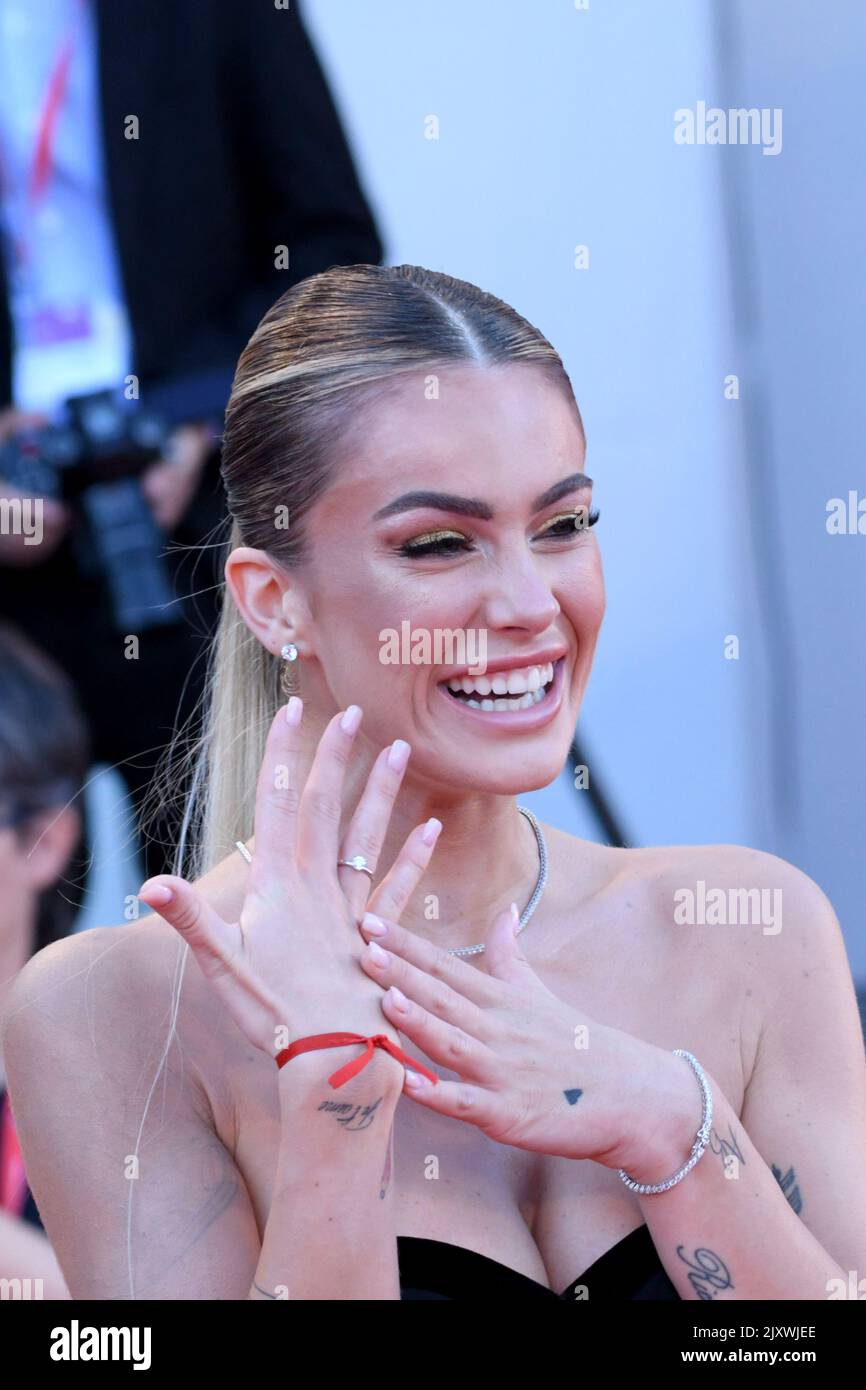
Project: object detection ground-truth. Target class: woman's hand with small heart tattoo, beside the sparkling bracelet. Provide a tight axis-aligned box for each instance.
[360,910,701,1183]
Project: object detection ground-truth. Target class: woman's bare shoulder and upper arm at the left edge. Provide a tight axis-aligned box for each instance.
[3,915,259,1298]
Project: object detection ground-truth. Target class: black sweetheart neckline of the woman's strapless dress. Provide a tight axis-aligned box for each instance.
[398,1225,680,1304]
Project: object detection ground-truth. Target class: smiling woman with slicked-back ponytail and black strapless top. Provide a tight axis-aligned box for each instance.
[7,265,866,1301]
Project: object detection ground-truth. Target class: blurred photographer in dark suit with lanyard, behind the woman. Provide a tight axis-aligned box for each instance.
[0,0,382,874]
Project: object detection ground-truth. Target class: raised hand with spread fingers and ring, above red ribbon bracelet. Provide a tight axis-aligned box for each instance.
[139,696,441,1065]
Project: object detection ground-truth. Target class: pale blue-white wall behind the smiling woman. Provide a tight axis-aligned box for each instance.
[82,0,866,979]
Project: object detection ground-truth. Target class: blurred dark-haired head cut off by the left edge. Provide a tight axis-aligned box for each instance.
[0,623,89,981]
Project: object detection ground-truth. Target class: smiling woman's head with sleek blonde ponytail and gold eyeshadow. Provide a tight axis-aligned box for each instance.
[166,265,605,873]
